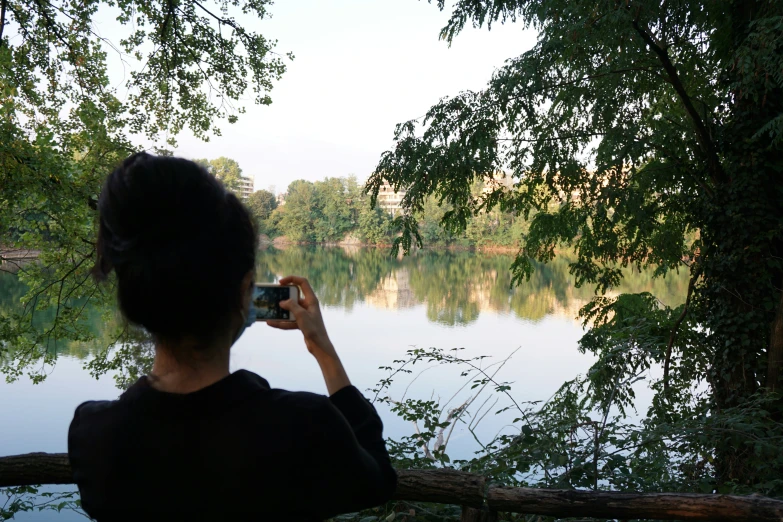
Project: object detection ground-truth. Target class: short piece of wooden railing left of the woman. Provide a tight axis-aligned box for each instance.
[0,453,73,487]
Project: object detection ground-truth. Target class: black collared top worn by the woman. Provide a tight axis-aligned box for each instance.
[68,370,397,522]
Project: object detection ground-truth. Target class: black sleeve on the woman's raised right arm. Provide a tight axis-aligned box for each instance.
[302,386,397,518]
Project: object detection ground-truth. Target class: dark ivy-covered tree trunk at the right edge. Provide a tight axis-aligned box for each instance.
[700,0,783,486]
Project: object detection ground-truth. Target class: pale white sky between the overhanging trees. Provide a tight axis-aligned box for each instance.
[167,0,536,193]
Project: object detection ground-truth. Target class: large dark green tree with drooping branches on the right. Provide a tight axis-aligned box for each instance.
[368,0,783,494]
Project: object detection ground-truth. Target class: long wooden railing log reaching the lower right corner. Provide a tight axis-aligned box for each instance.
[487,486,783,522]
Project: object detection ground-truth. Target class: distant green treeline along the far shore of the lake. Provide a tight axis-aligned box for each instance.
[246,177,527,247]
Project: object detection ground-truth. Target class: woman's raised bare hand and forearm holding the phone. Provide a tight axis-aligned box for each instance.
[266,276,351,395]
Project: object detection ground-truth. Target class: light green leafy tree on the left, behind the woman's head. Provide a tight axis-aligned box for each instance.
[0,0,285,379]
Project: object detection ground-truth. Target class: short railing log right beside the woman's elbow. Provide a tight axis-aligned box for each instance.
[394,469,487,507]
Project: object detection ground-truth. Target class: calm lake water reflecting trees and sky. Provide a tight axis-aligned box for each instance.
[0,247,688,520]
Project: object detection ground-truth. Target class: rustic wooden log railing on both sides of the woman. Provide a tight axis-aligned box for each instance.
[0,453,783,522]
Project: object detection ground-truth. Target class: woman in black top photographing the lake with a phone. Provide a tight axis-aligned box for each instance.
[68,153,397,522]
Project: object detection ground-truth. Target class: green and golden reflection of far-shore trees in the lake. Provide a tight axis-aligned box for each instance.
[258,247,687,325]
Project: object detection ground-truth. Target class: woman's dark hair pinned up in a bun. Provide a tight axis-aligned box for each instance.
[95,152,257,341]
